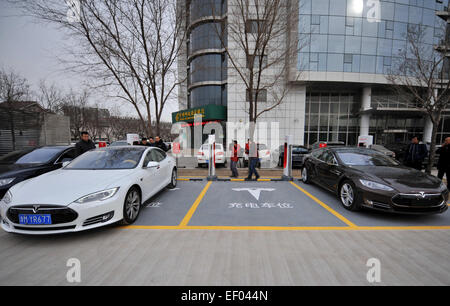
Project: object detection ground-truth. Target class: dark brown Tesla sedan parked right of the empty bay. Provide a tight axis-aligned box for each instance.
[302,147,449,214]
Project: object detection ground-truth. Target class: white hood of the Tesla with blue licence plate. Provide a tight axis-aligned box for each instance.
[10,169,132,205]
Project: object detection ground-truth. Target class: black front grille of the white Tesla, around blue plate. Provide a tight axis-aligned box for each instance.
[6,205,78,225]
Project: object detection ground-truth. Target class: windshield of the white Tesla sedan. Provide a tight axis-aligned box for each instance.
[65,148,144,170]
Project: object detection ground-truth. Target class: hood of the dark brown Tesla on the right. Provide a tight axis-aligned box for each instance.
[351,166,442,193]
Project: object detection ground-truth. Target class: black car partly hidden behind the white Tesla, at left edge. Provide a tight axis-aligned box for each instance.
[0,146,77,199]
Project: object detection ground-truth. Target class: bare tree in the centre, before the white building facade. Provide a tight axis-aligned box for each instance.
[210,0,305,137]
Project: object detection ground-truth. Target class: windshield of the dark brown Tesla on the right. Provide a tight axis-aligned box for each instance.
[337,152,399,166]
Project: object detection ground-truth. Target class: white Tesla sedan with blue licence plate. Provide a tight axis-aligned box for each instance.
[0,146,177,235]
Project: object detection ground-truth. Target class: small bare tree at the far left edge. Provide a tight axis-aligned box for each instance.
[0,70,30,151]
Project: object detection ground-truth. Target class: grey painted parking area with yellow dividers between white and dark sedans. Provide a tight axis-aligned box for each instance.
[129,181,450,230]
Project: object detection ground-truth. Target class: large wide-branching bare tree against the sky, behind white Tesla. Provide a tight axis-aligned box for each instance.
[10,0,183,135]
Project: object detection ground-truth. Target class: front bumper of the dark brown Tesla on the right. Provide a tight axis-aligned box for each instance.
[359,188,449,215]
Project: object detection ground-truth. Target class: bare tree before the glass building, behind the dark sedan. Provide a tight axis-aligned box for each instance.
[387,25,450,173]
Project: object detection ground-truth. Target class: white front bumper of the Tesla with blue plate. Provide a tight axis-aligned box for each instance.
[0,195,125,235]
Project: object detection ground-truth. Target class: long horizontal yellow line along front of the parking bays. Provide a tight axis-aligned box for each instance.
[122,225,450,231]
